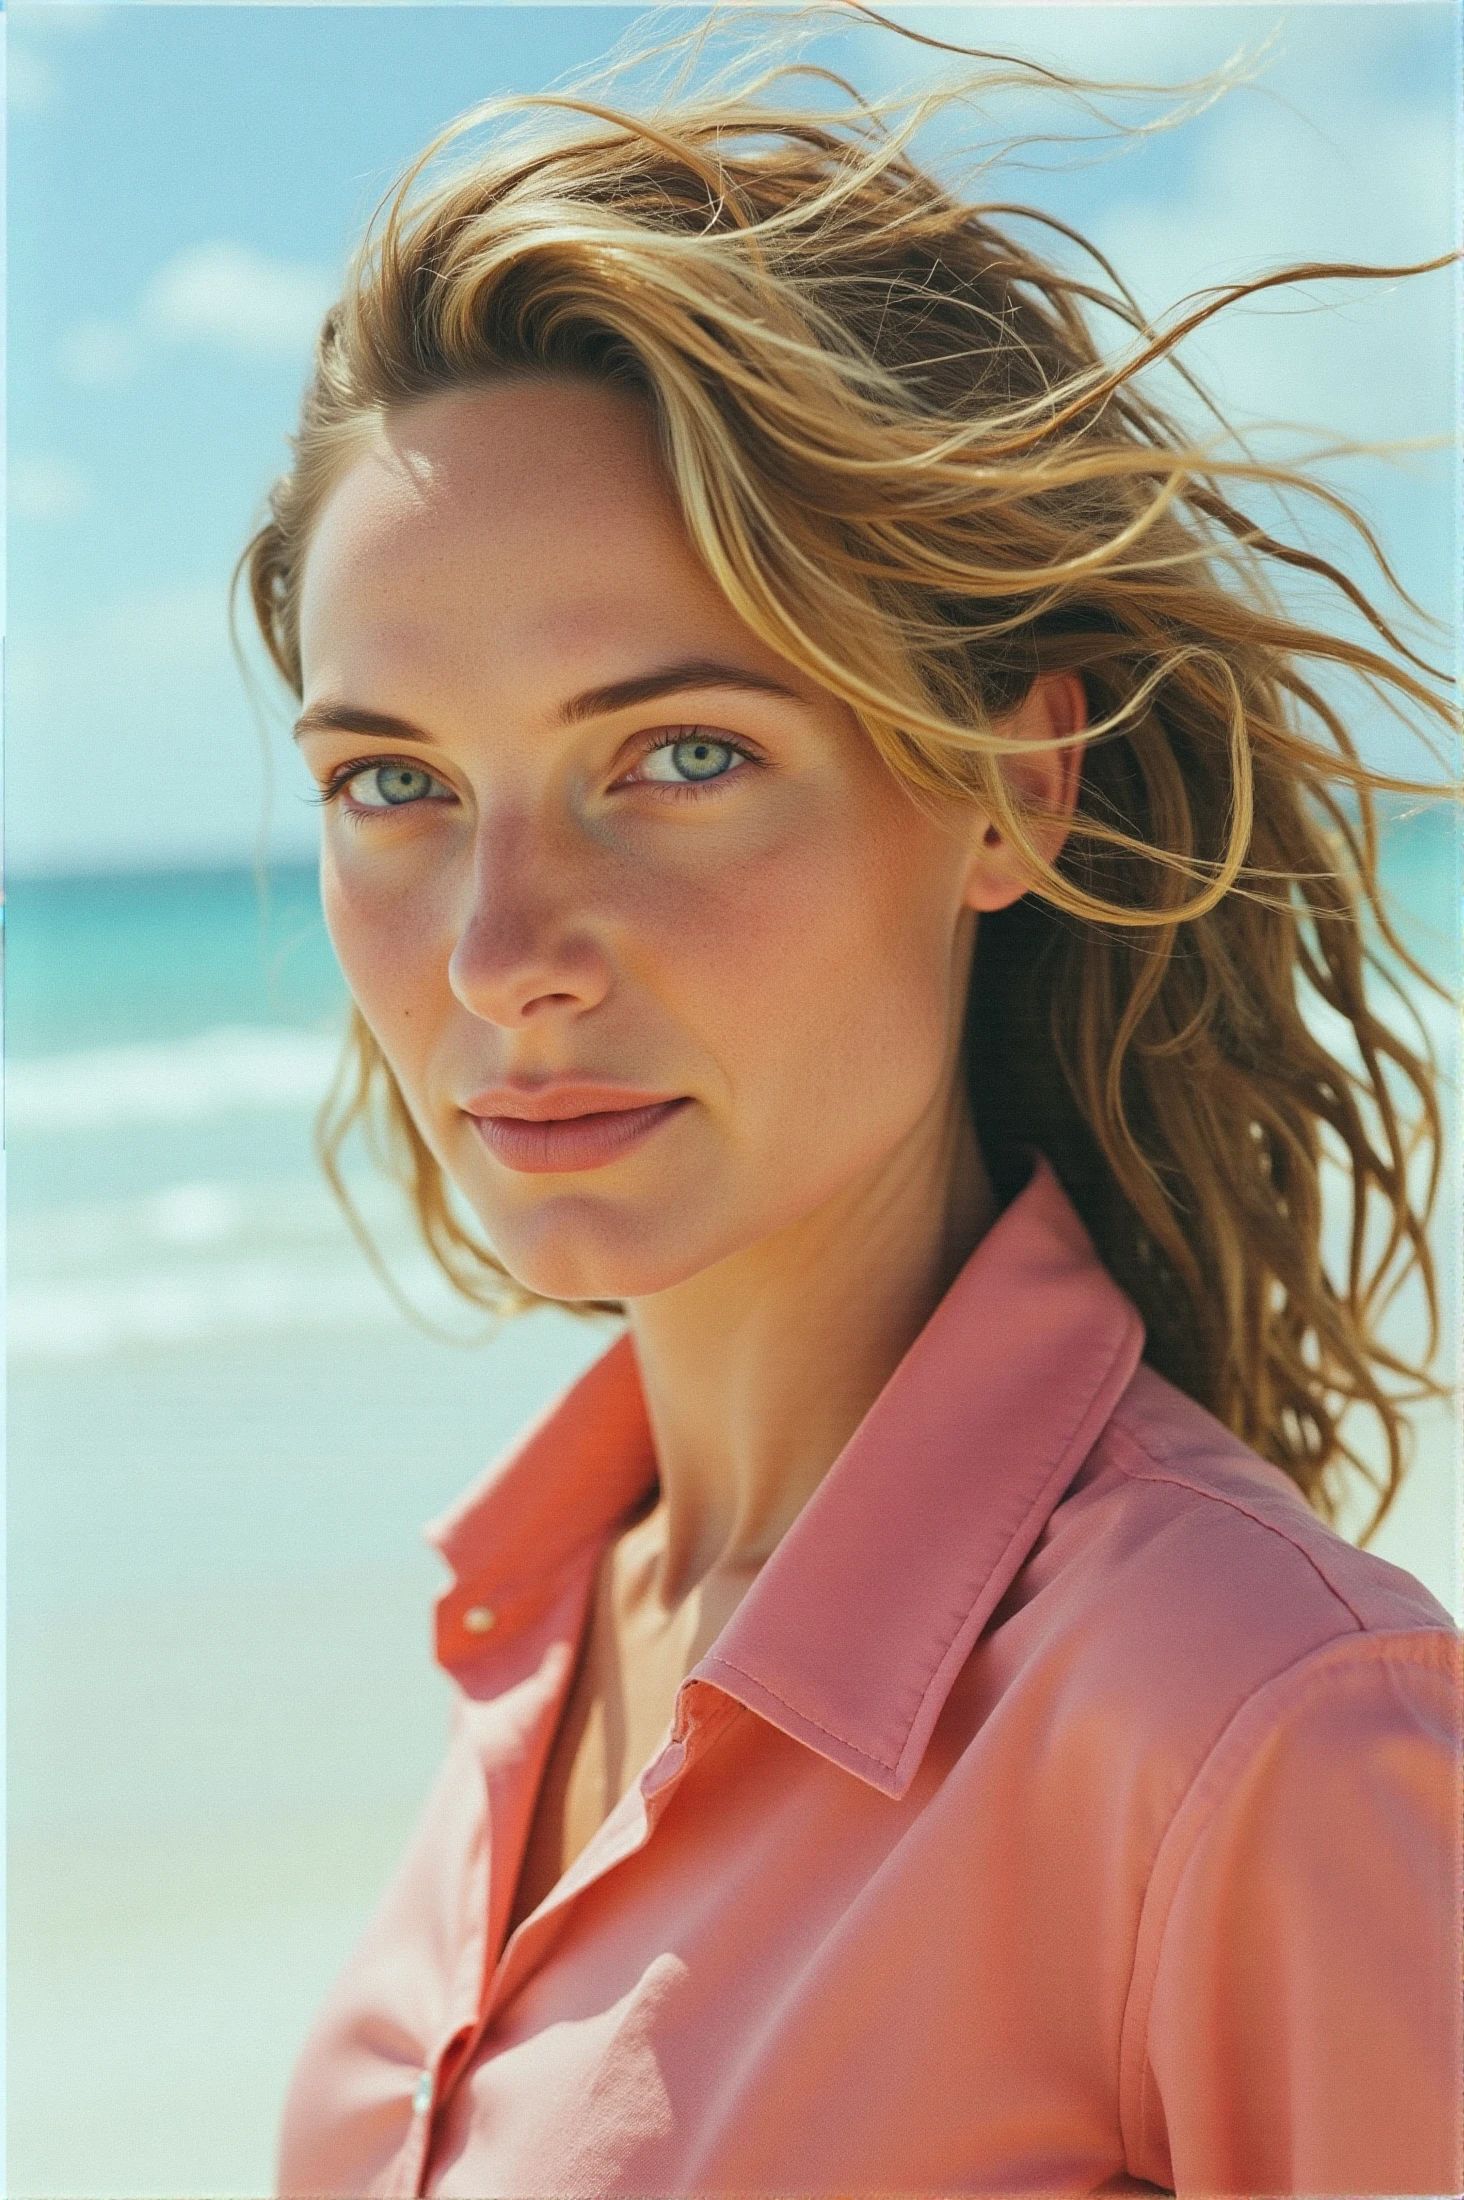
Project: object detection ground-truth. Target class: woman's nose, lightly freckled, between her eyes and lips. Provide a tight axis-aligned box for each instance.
[447,810,610,1030]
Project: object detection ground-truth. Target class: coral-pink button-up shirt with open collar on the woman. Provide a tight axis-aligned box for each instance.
[280,1162,1464,2200]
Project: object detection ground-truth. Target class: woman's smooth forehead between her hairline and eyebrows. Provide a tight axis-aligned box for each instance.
[299,378,751,690]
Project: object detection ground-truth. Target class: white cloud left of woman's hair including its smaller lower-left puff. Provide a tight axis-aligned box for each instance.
[57,238,337,389]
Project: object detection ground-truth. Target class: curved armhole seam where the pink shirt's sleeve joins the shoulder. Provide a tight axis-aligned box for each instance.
[1116,1628,1451,2176]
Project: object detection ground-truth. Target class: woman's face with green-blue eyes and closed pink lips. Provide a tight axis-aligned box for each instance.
[299,378,1025,1298]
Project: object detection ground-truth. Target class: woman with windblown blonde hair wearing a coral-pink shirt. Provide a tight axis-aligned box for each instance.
[236,21,1460,2196]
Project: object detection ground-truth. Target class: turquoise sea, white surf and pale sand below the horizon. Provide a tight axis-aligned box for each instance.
[7,810,1460,2196]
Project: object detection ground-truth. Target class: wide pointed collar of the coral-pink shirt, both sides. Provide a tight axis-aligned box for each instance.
[427,1155,1143,1797]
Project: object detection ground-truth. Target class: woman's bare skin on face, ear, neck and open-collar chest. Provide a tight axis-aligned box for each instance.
[302,381,1081,1821]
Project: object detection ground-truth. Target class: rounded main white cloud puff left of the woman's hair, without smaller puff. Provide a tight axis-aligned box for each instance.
[141,238,335,359]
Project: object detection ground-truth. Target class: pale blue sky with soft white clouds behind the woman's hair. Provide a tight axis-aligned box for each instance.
[7,0,1457,873]
